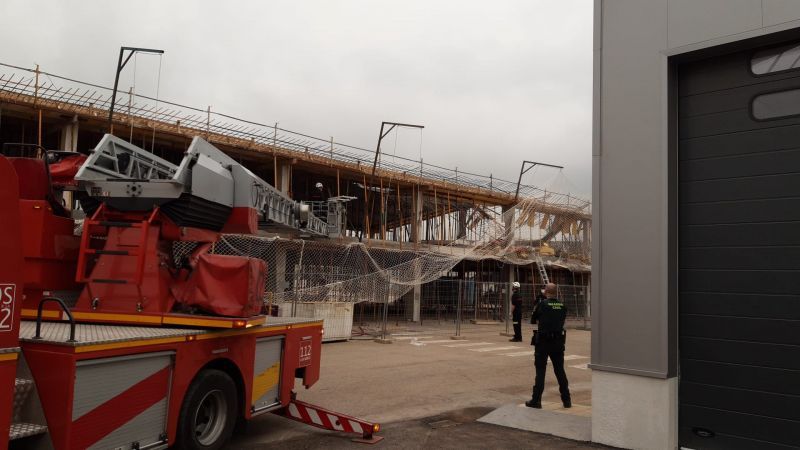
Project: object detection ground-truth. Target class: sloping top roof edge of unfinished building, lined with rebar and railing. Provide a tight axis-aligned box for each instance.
[0,63,591,205]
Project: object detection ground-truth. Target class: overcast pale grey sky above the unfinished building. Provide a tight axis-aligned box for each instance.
[0,0,592,198]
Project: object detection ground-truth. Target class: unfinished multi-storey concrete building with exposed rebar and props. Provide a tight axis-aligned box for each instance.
[0,64,591,331]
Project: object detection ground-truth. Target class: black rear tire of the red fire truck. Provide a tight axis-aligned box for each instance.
[175,369,238,450]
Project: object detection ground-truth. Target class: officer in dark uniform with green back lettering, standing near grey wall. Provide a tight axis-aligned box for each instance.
[525,283,572,408]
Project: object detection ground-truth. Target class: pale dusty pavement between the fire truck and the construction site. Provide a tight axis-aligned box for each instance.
[230,324,591,448]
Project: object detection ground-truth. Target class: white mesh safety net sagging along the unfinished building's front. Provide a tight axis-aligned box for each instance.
[175,195,591,304]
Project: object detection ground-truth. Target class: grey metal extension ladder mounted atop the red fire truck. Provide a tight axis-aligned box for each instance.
[75,134,340,237]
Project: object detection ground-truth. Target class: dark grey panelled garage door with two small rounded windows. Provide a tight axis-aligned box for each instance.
[678,40,800,449]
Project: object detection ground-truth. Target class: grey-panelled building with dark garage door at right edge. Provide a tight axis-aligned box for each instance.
[590,0,800,449]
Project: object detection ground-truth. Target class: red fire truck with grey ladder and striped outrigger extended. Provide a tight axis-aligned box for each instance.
[0,135,379,449]
